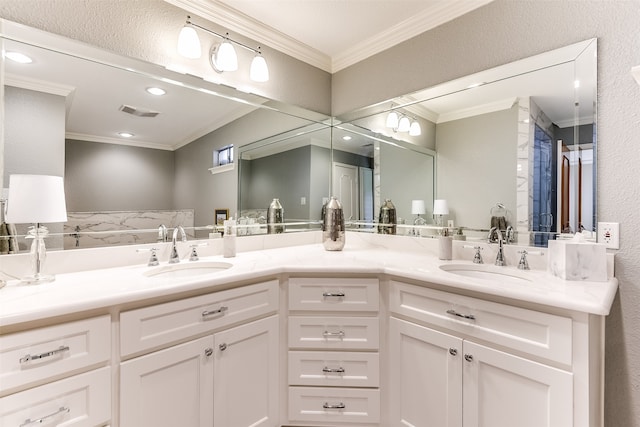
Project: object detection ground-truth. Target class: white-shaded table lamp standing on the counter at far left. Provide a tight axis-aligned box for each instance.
[6,175,67,284]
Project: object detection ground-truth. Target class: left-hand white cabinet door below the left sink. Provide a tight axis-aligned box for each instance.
[120,336,214,427]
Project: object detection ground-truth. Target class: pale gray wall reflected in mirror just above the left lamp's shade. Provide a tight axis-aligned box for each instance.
[4,86,65,181]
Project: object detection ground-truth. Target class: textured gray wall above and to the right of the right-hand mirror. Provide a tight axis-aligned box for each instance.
[332,0,640,427]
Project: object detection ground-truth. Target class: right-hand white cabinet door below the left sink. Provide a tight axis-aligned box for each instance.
[213,316,279,427]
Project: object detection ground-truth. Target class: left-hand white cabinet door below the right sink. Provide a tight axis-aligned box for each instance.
[389,318,462,427]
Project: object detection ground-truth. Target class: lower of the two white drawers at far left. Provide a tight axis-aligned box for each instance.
[0,368,111,427]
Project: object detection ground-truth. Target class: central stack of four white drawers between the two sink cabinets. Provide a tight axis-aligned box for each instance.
[288,277,381,426]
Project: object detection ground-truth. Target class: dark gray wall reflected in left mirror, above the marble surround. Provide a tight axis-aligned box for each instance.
[65,140,175,212]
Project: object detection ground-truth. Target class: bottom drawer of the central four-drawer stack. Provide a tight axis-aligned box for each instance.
[289,387,380,424]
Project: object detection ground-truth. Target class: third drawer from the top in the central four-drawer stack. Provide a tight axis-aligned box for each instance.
[289,351,380,387]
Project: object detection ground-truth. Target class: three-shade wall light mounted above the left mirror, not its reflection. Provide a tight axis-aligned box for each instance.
[178,16,269,82]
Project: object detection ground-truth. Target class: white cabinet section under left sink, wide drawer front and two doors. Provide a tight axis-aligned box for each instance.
[120,281,279,427]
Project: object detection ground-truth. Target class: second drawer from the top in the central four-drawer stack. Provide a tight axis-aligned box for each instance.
[289,316,380,350]
